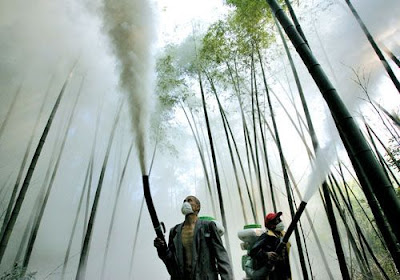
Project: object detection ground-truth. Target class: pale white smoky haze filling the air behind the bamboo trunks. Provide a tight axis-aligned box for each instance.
[0,0,400,279]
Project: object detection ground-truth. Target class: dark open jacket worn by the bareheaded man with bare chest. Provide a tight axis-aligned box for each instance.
[158,220,233,280]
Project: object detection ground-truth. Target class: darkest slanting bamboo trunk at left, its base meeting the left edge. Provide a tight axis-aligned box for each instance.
[0,63,76,263]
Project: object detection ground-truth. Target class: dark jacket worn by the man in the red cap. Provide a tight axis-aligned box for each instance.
[249,230,291,280]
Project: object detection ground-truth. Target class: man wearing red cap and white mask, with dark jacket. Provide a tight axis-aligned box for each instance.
[249,212,291,280]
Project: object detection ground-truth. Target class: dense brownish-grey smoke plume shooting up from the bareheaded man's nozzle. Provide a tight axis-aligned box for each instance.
[103,0,156,174]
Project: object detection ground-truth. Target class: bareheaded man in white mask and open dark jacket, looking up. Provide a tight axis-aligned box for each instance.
[154,196,233,280]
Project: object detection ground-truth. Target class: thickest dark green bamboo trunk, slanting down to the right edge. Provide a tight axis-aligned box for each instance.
[267,0,400,242]
